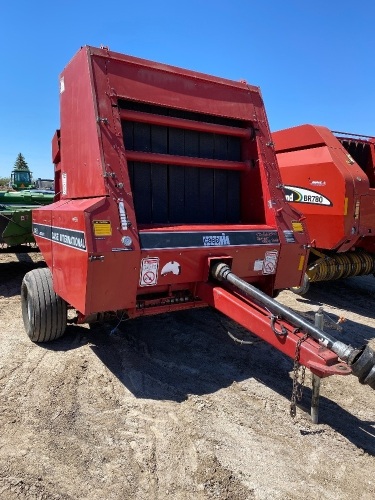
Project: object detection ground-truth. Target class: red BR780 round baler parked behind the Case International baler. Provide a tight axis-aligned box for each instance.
[272,125,375,294]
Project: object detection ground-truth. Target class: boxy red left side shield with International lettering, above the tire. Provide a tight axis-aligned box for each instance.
[33,197,140,315]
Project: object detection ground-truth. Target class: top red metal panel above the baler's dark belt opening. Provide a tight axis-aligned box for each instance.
[88,48,259,120]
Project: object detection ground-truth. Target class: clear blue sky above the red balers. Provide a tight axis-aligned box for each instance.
[0,0,375,177]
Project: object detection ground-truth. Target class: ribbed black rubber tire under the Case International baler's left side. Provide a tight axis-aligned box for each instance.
[21,267,67,342]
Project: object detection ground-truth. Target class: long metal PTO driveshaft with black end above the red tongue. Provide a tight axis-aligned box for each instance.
[211,262,375,389]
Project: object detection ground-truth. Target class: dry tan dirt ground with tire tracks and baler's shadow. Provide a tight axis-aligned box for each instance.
[0,253,375,500]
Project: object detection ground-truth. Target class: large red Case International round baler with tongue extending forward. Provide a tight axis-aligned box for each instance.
[21,47,375,414]
